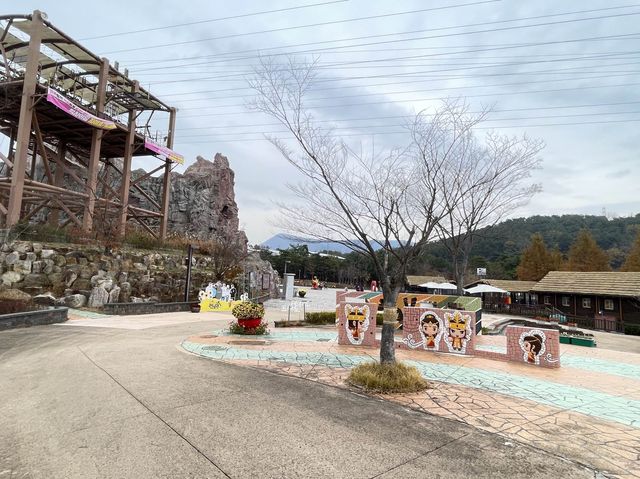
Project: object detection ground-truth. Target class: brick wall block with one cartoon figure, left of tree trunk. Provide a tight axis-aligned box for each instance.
[338,301,376,346]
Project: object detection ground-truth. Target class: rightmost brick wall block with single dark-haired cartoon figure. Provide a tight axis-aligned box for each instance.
[507,326,560,368]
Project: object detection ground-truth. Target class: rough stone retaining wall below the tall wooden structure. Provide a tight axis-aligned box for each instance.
[0,242,278,308]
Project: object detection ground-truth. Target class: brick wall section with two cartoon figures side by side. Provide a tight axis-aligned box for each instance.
[402,307,476,355]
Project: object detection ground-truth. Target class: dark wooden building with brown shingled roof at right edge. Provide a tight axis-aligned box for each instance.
[531,271,640,324]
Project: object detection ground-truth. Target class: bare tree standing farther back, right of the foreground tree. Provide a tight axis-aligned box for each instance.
[412,101,544,295]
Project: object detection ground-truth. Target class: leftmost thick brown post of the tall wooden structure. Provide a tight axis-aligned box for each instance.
[6,10,43,227]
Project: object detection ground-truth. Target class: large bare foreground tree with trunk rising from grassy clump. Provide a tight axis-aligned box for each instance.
[249,59,492,363]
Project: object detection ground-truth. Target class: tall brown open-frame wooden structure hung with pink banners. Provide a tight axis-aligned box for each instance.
[0,10,183,238]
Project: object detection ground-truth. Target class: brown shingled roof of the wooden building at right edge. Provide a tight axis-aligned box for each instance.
[533,271,640,297]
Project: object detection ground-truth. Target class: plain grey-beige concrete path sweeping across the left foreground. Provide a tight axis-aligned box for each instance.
[0,315,595,479]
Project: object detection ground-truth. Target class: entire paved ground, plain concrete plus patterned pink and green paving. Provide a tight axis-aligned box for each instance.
[0,302,640,479]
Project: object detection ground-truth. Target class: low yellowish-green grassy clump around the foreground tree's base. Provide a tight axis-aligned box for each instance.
[347,362,428,393]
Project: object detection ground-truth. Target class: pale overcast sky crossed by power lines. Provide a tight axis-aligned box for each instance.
[5,0,640,244]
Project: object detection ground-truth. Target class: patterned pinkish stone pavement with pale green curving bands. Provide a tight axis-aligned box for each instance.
[182,328,640,478]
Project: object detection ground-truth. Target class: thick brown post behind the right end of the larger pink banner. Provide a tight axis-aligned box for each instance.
[82,58,109,233]
